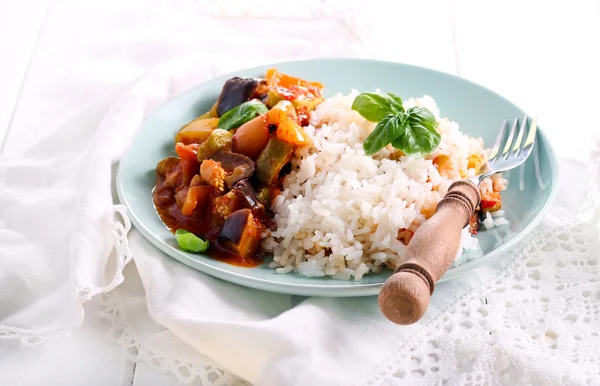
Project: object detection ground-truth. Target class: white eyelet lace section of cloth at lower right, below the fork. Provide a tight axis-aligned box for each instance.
[357,225,600,385]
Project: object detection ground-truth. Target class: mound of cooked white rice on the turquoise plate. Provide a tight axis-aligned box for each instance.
[262,91,493,280]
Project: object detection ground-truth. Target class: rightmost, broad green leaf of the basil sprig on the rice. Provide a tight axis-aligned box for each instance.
[391,107,442,158]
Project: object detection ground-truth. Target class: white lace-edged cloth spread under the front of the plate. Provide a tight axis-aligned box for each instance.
[106,153,600,385]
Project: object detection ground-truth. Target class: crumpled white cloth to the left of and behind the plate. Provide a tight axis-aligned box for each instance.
[0,0,370,343]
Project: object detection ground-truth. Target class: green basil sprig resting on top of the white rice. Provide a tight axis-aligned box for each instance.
[352,93,441,157]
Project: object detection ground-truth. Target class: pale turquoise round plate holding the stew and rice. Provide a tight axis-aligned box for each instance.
[117,59,558,296]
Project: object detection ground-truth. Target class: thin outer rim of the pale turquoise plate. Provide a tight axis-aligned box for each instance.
[115,57,559,297]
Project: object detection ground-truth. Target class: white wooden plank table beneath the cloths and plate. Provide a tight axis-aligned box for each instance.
[0,0,600,386]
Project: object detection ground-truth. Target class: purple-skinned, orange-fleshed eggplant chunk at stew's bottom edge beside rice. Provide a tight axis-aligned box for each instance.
[219,209,260,258]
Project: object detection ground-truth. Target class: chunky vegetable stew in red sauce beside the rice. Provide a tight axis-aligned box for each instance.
[152,68,323,266]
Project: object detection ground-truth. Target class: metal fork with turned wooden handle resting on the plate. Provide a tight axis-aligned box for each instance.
[379,115,537,324]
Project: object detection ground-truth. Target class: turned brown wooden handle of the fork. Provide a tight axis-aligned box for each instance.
[379,181,481,324]
